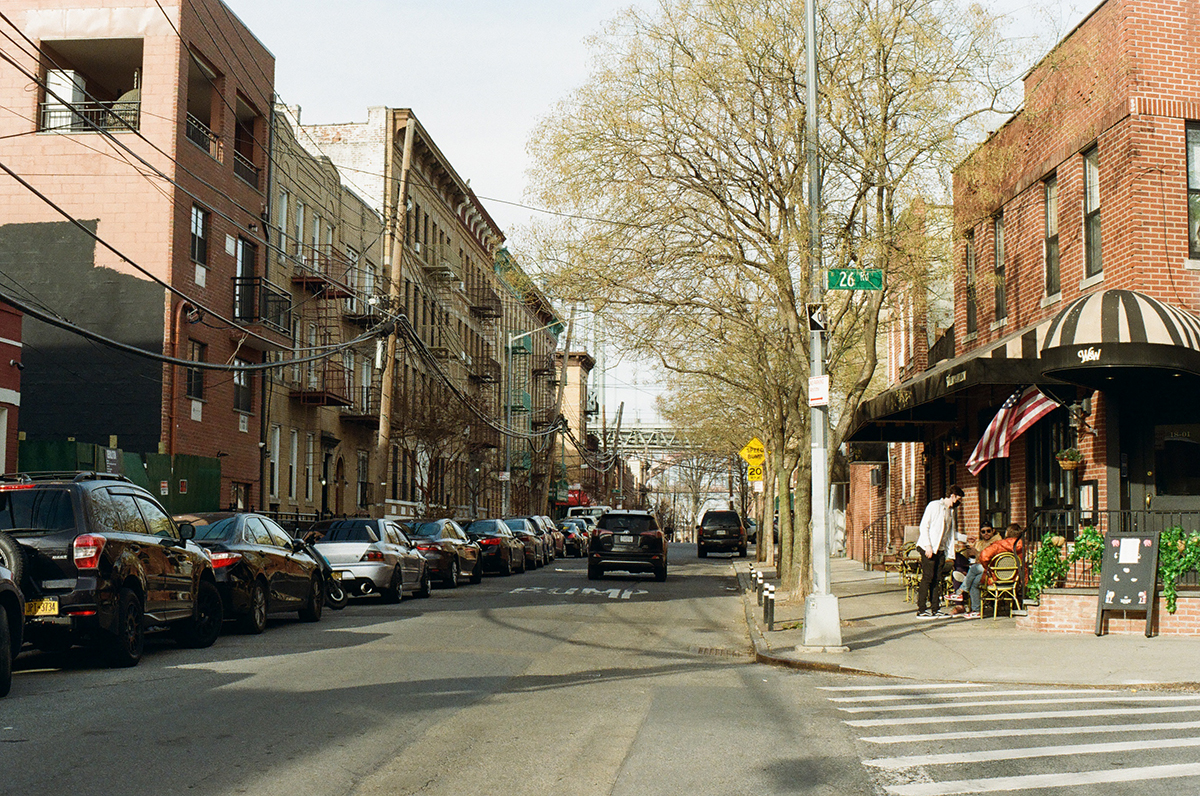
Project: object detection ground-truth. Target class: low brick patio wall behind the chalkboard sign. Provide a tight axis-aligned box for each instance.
[1016,588,1200,636]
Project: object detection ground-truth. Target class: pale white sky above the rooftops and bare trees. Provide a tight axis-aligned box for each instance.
[226,0,1099,424]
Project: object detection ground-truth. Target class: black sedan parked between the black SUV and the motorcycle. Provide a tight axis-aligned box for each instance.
[175,511,325,634]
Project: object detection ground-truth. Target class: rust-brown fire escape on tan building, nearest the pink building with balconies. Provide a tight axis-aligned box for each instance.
[288,245,354,407]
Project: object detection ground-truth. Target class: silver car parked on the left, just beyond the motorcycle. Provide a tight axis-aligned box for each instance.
[306,517,432,603]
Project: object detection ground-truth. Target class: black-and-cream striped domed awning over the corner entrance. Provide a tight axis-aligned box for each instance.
[1042,289,1200,387]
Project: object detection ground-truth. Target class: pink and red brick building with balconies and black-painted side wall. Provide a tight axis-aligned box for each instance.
[0,0,276,507]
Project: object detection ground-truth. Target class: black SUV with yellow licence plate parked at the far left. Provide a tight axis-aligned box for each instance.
[0,472,223,666]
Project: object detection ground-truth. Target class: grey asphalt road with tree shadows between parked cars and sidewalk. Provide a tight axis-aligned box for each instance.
[0,545,880,796]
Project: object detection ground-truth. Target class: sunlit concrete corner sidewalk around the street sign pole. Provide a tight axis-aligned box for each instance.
[733,558,1200,688]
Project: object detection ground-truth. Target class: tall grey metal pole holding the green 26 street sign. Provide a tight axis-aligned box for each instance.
[803,0,841,647]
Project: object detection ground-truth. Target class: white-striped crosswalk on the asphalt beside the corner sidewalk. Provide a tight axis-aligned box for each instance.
[821,682,1200,796]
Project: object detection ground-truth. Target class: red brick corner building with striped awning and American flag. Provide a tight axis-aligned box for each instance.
[851,0,1200,576]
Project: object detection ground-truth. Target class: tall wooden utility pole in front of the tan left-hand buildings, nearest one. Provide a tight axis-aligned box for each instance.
[376,112,416,516]
